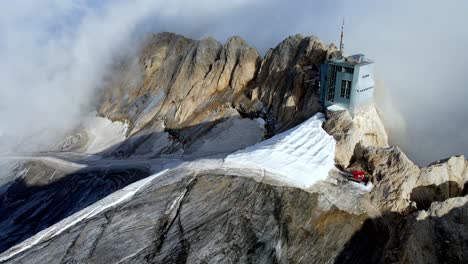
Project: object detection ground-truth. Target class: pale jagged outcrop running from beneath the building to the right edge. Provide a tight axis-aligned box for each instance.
[324,105,468,213]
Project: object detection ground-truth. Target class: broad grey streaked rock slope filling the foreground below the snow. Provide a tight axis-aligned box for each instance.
[0,165,468,263]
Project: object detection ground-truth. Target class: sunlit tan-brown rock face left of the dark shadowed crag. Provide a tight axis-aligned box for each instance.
[99,33,260,156]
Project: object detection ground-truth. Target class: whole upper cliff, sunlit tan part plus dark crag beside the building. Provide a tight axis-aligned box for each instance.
[99,33,327,156]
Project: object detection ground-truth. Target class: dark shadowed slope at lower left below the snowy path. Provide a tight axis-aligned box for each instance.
[0,161,149,252]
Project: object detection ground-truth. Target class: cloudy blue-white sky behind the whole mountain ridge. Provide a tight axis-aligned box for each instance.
[0,0,468,163]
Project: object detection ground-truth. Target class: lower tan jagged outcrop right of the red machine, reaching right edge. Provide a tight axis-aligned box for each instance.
[350,145,468,213]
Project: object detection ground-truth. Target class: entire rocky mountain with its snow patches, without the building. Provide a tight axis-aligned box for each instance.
[0,33,468,263]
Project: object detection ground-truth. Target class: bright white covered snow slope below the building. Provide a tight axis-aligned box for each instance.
[225,113,335,188]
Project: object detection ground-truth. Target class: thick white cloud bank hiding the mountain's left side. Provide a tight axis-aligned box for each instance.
[0,0,252,151]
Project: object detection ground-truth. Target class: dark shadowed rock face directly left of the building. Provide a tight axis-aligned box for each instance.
[252,35,328,131]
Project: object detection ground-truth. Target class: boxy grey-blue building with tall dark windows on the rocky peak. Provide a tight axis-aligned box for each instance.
[320,54,375,112]
